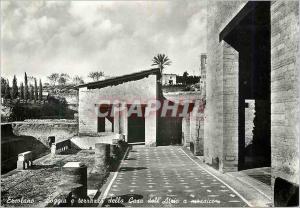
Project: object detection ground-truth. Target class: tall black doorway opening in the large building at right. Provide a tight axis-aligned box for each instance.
[220,1,271,170]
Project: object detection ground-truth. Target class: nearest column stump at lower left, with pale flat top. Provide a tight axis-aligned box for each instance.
[61,162,87,199]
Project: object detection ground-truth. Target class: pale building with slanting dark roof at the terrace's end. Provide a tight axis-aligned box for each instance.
[78,70,160,145]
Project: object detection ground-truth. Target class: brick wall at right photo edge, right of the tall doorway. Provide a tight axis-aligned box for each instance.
[271,1,300,188]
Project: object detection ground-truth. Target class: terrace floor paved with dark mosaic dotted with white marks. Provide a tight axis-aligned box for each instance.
[103,146,247,207]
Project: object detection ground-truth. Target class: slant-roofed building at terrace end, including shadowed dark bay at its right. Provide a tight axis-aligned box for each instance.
[78,69,196,146]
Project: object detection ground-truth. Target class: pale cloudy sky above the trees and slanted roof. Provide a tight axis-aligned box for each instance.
[1,0,206,81]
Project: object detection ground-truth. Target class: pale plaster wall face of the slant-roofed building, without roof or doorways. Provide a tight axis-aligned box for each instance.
[78,75,157,145]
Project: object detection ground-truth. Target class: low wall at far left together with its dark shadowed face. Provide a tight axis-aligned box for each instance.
[1,119,78,173]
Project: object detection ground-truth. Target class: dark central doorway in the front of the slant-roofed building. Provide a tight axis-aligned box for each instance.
[128,107,145,143]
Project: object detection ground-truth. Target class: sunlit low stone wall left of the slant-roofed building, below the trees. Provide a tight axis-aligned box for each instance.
[12,119,78,146]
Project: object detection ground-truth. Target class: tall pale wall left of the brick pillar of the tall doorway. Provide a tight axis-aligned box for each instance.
[204,1,246,171]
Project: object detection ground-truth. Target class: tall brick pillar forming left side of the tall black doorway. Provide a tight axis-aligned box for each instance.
[219,41,239,172]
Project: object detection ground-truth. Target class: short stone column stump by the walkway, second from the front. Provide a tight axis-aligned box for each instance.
[95,143,110,174]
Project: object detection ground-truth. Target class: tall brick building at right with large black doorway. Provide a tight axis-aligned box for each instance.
[204,1,300,205]
